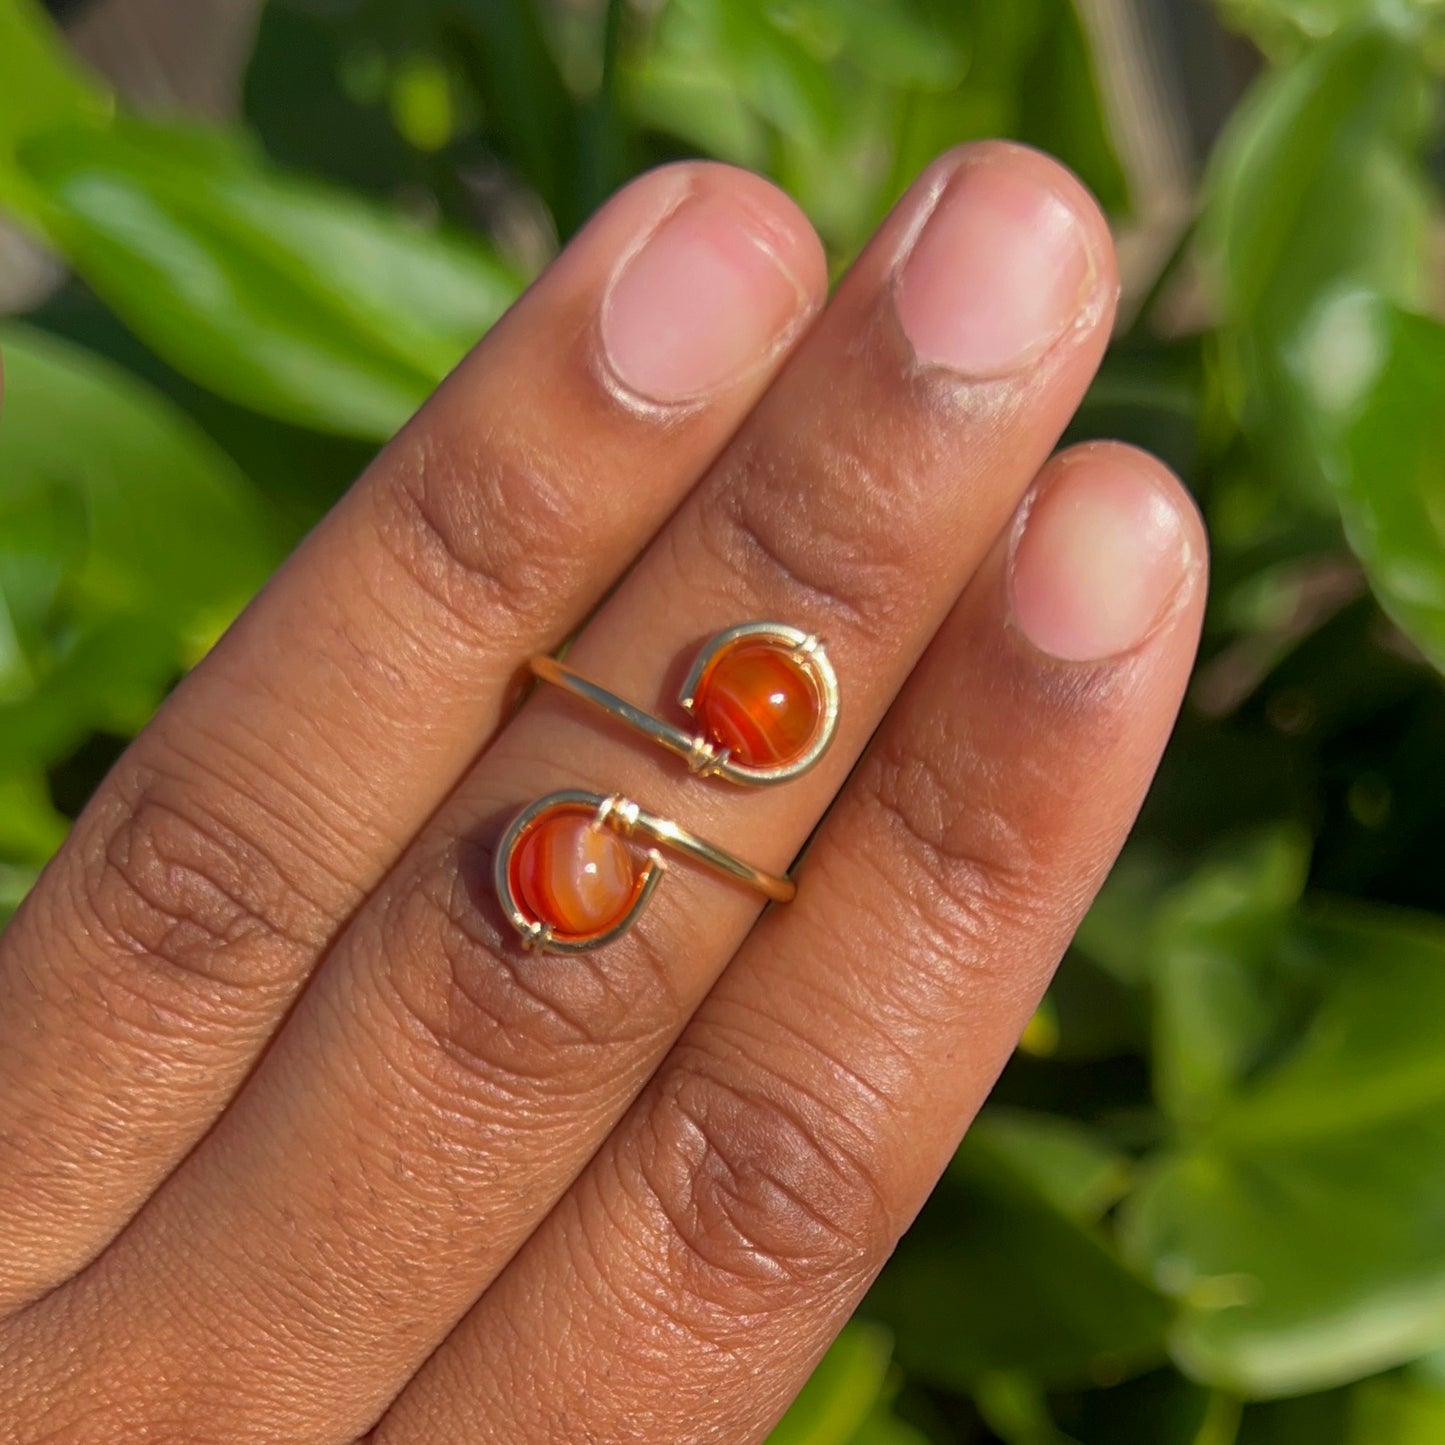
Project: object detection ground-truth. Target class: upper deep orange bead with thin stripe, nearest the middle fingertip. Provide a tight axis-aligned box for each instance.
[695,640,822,769]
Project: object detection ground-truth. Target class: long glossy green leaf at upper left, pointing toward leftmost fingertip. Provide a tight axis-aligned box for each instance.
[9,121,519,439]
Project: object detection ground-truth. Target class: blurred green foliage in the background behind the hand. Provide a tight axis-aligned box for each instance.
[0,0,1445,1445]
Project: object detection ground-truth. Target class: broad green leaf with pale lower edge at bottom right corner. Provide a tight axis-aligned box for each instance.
[1124,906,1445,1397]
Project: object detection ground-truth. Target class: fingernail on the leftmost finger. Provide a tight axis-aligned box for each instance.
[601,197,808,403]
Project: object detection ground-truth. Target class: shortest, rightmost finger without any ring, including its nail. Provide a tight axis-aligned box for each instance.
[371,447,1204,1445]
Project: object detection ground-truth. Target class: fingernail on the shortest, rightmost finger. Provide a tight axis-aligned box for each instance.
[1012,455,1192,662]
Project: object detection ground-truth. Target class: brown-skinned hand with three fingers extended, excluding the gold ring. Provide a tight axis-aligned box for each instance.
[0,145,1205,1445]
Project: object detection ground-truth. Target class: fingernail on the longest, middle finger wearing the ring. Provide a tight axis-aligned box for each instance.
[897,162,1097,379]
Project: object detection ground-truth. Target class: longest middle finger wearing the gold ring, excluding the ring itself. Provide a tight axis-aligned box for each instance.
[2,146,1114,1442]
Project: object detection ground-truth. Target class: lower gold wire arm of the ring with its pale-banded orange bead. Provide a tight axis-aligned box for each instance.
[493,790,796,954]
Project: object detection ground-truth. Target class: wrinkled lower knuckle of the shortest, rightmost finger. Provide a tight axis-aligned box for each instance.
[637,1056,897,1325]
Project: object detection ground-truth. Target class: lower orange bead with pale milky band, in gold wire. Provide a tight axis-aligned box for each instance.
[512,808,642,938]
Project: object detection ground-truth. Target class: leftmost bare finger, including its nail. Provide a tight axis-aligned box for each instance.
[0,165,825,1308]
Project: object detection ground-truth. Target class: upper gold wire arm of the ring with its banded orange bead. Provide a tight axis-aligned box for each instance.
[529,623,838,786]
